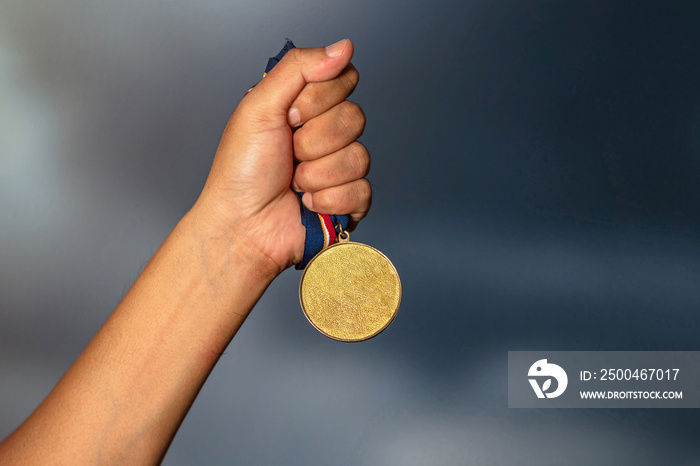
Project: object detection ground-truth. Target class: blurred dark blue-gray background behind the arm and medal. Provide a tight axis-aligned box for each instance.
[0,0,700,465]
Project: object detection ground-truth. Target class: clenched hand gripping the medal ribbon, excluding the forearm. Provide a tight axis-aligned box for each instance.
[195,39,371,273]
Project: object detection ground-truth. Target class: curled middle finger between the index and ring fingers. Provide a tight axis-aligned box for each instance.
[294,100,366,162]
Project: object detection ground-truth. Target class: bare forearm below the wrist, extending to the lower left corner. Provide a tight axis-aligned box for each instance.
[0,206,277,464]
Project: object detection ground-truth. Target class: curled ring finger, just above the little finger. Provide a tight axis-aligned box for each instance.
[294,141,370,193]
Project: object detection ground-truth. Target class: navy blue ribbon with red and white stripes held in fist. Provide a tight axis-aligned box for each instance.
[248,39,350,270]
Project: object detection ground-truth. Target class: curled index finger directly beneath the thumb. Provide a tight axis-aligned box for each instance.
[288,63,360,128]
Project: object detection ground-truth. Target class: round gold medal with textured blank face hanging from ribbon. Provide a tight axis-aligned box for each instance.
[299,241,401,341]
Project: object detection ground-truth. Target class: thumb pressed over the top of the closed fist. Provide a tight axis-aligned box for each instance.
[246,39,353,120]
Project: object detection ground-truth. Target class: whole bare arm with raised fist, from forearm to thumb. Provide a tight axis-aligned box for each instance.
[0,40,371,465]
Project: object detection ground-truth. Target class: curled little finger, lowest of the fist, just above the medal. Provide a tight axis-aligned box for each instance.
[302,178,372,231]
